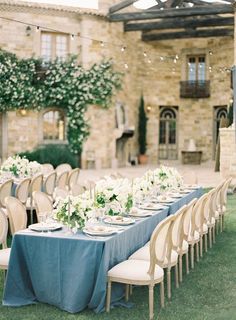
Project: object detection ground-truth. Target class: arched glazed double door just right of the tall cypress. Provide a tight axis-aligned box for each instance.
[159,107,178,160]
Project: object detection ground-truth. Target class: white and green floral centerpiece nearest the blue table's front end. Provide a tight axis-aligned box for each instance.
[54,191,94,233]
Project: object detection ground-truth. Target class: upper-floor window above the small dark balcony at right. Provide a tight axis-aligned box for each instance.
[187,55,206,81]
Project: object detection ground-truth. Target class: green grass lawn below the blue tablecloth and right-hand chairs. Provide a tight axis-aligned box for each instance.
[0,195,236,320]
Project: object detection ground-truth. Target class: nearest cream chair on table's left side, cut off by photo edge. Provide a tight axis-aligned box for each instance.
[0,209,11,270]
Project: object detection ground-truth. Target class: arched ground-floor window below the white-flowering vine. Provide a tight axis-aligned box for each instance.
[43,109,65,141]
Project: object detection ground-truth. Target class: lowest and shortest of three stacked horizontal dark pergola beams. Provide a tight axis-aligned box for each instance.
[142,28,234,41]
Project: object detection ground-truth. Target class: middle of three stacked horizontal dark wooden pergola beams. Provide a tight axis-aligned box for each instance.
[124,17,234,31]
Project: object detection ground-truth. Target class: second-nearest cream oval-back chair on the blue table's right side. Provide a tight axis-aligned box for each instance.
[129,205,186,299]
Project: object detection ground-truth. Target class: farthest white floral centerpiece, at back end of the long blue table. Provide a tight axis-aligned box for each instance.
[153,166,183,191]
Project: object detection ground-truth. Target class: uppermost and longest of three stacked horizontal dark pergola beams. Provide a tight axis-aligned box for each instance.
[108,5,234,21]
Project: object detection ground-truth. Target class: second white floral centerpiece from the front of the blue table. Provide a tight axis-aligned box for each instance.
[94,177,133,216]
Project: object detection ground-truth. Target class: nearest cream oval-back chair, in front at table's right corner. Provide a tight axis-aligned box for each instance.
[106,216,174,319]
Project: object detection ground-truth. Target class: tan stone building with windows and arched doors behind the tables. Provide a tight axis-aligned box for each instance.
[0,0,234,168]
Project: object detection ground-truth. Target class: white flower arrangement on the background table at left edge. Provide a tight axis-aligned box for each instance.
[0,155,41,178]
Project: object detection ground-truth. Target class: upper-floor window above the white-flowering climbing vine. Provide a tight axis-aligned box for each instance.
[41,32,69,62]
